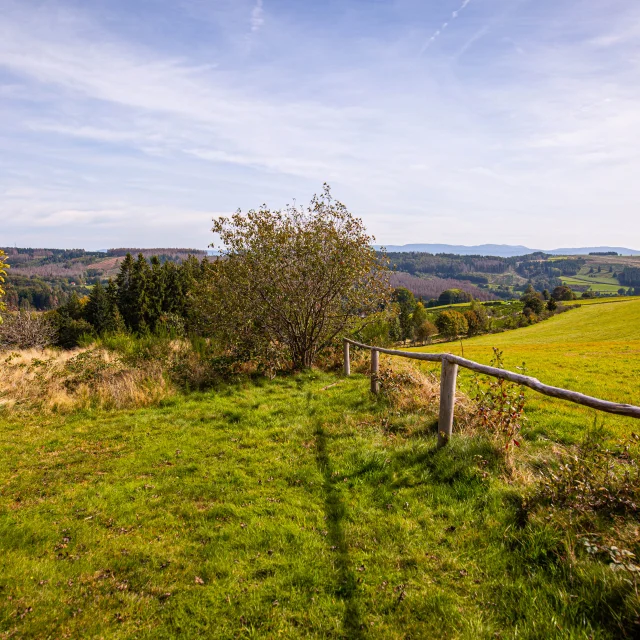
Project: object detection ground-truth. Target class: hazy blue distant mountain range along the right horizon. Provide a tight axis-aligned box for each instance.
[376,244,640,258]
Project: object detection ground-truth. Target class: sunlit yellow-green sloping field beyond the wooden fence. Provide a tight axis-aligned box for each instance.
[418,298,640,440]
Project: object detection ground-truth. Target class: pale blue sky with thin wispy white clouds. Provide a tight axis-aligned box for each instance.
[0,0,640,249]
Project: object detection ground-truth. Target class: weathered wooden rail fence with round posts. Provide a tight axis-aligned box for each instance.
[344,338,640,447]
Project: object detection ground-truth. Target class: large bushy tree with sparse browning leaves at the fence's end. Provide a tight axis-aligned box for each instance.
[200,185,390,368]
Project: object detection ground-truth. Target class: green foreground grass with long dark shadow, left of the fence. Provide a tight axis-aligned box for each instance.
[0,373,636,638]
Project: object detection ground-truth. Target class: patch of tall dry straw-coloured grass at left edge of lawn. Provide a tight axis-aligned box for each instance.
[0,348,174,413]
